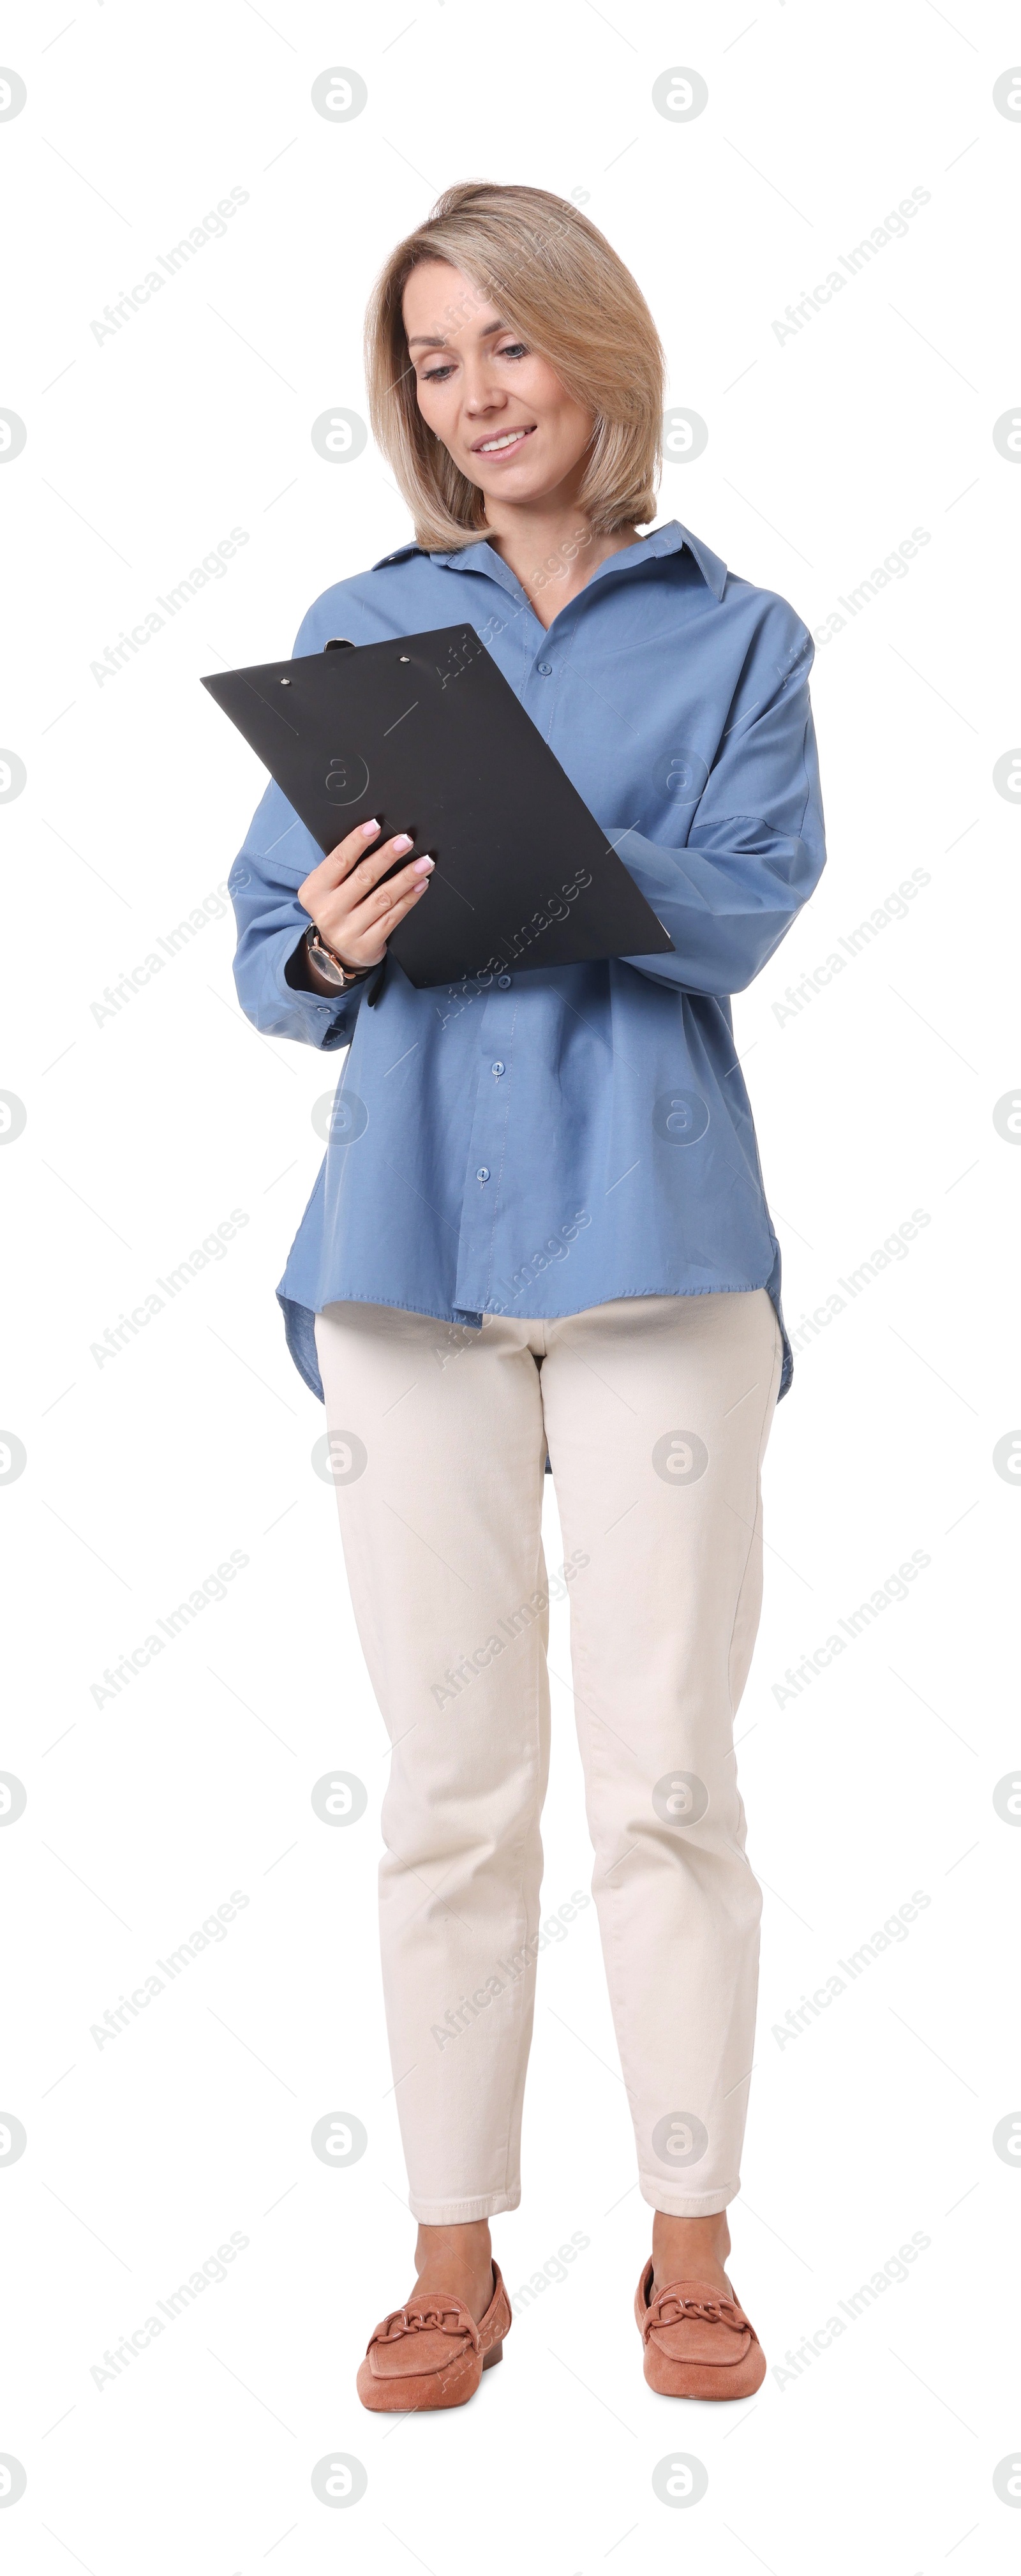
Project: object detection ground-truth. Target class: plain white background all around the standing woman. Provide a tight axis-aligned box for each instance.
[0,0,1021,2576]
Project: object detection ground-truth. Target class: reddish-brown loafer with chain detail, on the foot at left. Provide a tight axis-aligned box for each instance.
[359,2265,511,2414]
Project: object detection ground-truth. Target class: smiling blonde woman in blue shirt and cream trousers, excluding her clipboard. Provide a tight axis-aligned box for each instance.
[232,186,823,2411]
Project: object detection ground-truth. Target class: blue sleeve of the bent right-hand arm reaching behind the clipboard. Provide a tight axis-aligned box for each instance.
[609,603,825,994]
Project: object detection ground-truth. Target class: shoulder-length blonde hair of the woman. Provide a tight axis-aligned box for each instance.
[366,181,665,554]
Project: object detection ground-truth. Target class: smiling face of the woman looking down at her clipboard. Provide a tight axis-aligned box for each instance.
[402,260,595,505]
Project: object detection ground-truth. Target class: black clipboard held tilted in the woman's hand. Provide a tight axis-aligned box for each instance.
[201,626,673,984]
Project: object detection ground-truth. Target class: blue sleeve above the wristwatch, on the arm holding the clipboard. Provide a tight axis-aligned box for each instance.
[227,783,366,1049]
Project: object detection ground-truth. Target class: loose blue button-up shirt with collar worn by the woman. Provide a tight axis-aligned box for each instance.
[230,520,825,1397]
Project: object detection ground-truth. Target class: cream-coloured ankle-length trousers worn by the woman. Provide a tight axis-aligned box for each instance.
[317,1288,781,2226]
